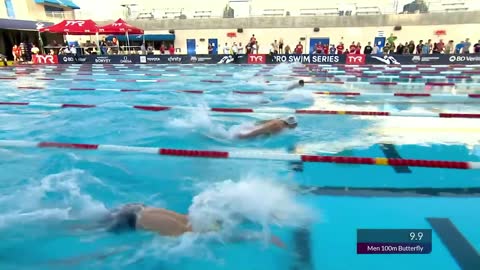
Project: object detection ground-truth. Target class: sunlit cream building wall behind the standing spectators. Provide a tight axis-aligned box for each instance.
[146,24,480,54]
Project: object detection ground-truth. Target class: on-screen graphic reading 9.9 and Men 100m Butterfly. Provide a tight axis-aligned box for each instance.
[357,229,432,254]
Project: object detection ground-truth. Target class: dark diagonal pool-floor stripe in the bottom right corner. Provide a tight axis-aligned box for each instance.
[426,218,480,270]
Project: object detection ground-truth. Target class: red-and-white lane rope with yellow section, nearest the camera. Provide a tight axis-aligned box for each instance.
[0,140,480,170]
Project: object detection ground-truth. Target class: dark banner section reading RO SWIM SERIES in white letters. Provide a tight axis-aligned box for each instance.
[267,54,345,64]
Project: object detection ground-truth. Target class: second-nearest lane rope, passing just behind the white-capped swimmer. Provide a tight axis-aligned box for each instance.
[0,101,480,119]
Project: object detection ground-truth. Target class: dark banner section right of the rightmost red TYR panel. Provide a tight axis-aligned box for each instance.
[366,54,480,65]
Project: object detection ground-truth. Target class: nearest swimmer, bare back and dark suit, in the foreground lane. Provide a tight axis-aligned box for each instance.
[77,203,285,248]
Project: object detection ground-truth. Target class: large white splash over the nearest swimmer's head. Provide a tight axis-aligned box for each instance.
[188,177,313,233]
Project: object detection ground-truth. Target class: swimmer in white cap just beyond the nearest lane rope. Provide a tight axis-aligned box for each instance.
[236,116,298,139]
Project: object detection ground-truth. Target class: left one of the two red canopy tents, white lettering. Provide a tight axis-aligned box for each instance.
[39,20,98,35]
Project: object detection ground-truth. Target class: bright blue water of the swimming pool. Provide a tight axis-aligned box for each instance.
[0,64,480,269]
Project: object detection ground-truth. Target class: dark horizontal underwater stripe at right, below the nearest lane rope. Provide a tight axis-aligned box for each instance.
[298,185,480,198]
